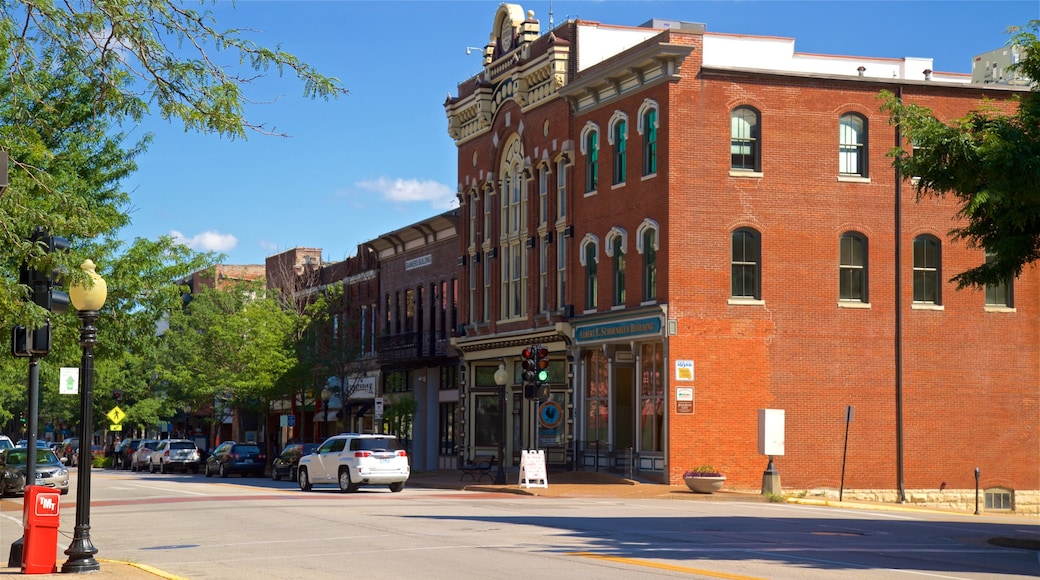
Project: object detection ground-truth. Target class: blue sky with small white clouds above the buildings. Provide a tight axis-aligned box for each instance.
[121,0,1040,264]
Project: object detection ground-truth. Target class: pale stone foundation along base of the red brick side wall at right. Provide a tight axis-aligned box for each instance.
[783,487,1040,516]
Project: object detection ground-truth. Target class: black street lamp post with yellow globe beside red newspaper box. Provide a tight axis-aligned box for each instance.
[61,260,108,574]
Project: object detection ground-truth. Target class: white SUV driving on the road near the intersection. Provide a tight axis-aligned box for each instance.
[298,433,410,492]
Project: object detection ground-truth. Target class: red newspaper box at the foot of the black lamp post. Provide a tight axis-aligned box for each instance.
[22,485,61,574]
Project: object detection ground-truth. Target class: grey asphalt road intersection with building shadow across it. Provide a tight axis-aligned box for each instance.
[0,471,1040,580]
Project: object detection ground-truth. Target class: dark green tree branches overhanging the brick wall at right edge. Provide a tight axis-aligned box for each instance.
[882,21,1040,288]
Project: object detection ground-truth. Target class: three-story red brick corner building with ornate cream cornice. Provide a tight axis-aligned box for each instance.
[445,4,1040,511]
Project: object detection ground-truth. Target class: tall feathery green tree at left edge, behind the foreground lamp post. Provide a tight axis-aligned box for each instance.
[0,0,346,436]
